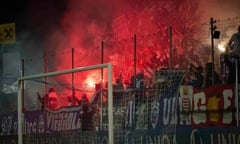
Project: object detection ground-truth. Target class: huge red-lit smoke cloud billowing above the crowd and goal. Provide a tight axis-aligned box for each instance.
[16,0,240,109]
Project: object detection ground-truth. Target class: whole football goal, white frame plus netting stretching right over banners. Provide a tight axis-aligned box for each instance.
[18,64,185,144]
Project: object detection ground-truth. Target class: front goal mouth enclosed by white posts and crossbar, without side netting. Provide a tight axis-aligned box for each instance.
[17,64,114,144]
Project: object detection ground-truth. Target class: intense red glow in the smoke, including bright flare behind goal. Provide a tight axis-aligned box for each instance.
[37,0,212,103]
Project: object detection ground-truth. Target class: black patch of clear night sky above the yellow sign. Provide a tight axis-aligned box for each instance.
[0,0,66,38]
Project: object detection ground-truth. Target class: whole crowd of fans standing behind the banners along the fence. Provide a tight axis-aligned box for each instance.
[37,23,240,130]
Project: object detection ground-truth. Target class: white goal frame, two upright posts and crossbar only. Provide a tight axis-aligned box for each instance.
[17,63,114,144]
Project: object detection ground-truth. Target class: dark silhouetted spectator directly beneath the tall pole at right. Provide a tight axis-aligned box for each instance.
[205,63,221,88]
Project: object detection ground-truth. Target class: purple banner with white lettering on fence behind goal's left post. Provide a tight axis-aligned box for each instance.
[0,107,81,135]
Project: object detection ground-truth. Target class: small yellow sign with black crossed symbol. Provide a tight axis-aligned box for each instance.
[0,23,16,44]
